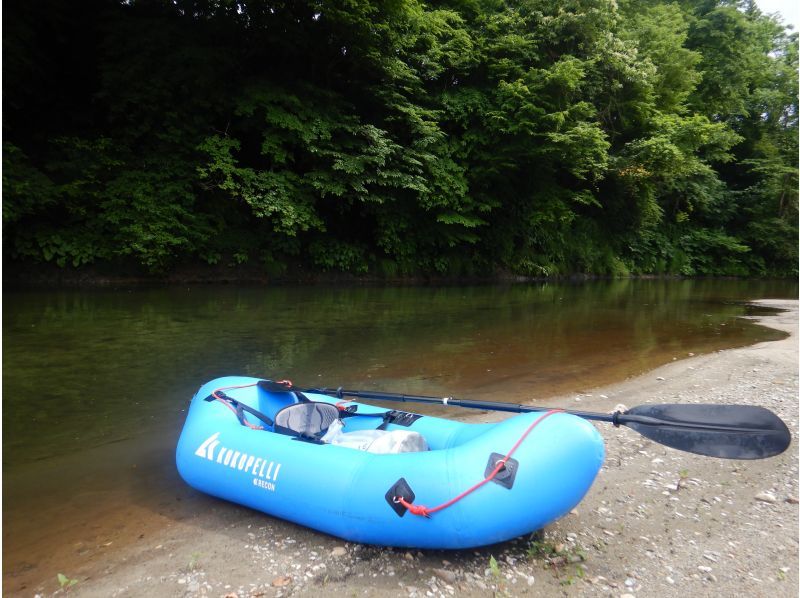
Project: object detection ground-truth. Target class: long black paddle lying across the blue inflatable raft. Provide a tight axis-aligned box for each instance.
[258,380,792,459]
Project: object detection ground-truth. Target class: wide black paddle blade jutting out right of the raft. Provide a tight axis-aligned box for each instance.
[617,404,792,459]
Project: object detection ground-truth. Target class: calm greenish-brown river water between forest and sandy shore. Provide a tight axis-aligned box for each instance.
[2,280,798,595]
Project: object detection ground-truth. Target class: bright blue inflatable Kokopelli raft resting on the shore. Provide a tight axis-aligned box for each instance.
[177,377,604,548]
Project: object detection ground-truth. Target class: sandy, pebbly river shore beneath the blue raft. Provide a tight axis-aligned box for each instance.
[21,300,798,598]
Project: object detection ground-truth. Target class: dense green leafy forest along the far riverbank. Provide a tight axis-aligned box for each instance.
[3,0,798,279]
